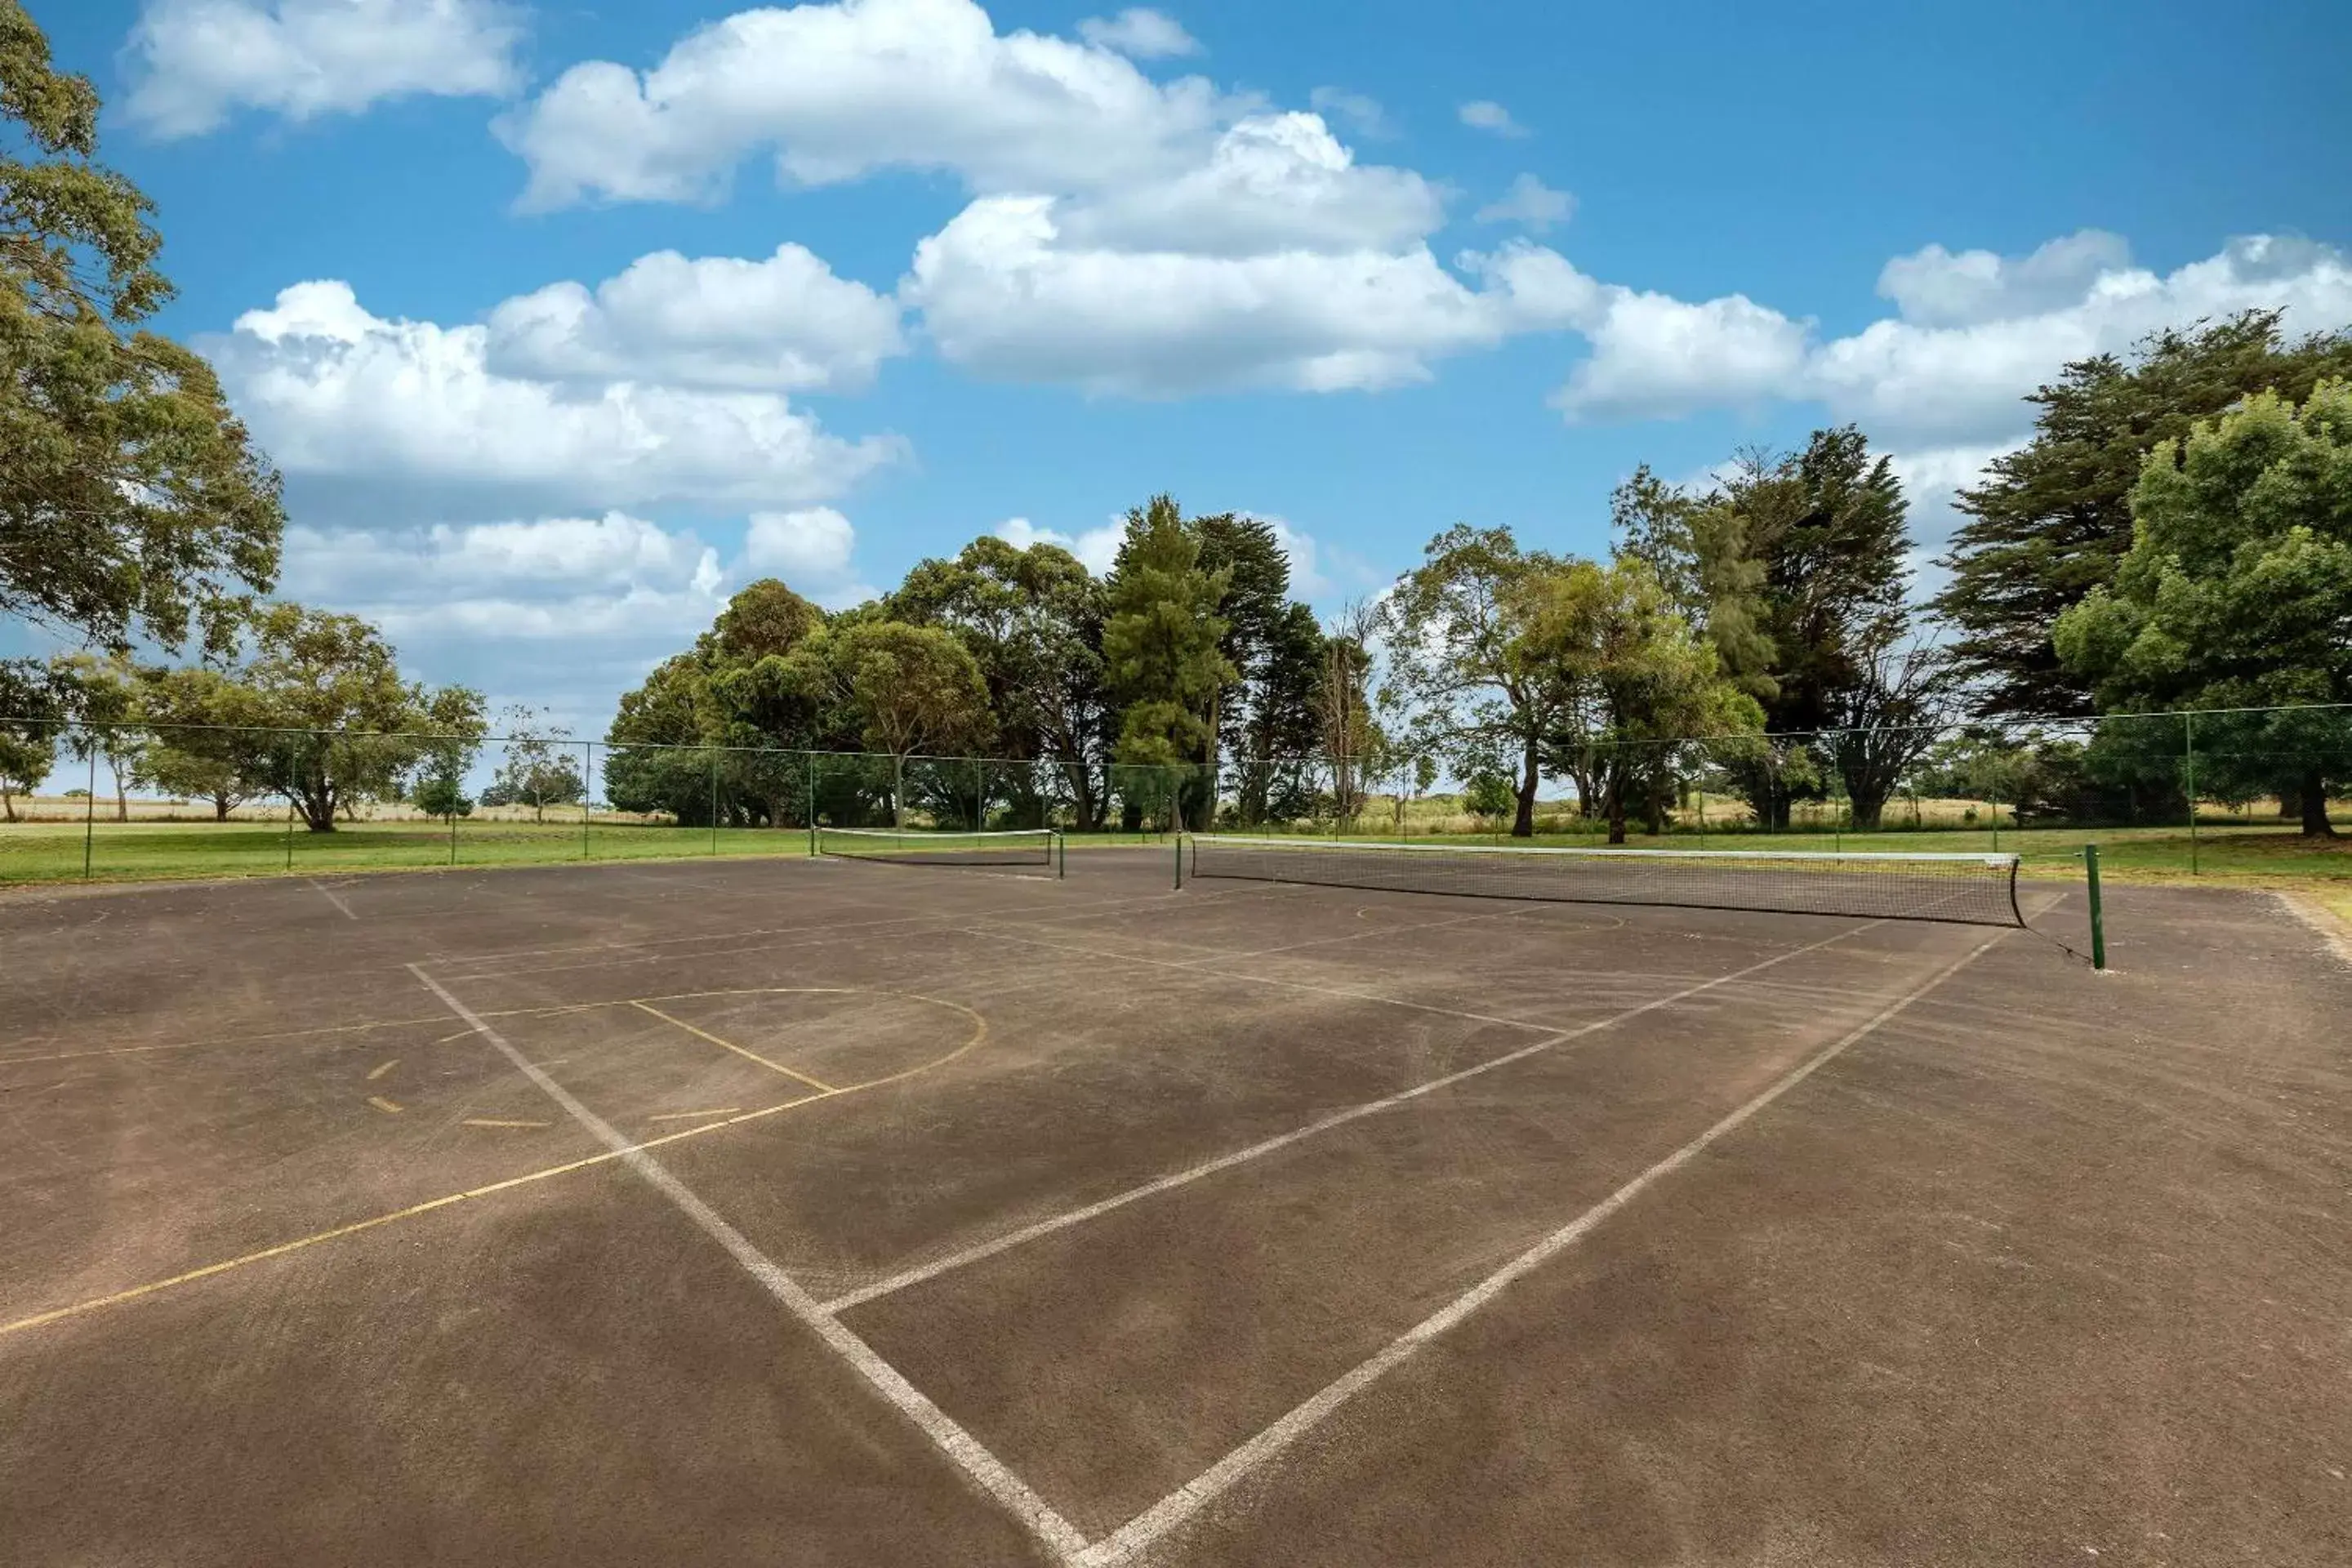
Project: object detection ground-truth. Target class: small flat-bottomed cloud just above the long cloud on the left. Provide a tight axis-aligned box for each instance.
[489,244,906,393]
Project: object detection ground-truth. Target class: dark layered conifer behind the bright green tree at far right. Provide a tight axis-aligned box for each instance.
[1936,310,2352,717]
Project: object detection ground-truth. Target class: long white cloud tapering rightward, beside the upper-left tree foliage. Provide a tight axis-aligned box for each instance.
[207,280,901,514]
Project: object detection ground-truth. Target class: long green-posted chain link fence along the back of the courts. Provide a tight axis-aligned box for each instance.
[0,706,2352,881]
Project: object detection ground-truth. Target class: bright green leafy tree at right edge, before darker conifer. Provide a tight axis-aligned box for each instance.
[2053,381,2352,837]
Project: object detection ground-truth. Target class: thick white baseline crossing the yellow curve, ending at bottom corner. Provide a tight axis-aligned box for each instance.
[407,964,1087,1561]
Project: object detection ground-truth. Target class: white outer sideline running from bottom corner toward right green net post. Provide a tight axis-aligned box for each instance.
[1075,931,2009,1568]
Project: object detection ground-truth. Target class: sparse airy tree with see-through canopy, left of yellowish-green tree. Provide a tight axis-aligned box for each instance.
[1383,522,1574,840]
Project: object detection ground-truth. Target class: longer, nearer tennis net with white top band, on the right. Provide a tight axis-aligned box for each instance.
[1187,832,2025,926]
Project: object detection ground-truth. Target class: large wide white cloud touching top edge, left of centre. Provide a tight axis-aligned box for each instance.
[501,0,1246,207]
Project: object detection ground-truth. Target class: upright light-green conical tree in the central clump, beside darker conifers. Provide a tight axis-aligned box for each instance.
[1103,496,1240,827]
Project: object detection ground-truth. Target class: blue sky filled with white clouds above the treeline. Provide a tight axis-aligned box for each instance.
[19,0,2352,733]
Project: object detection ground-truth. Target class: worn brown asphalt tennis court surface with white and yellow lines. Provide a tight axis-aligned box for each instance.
[0,851,2352,1566]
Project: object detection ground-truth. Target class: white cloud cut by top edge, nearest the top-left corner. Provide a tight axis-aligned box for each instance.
[125,0,522,136]
